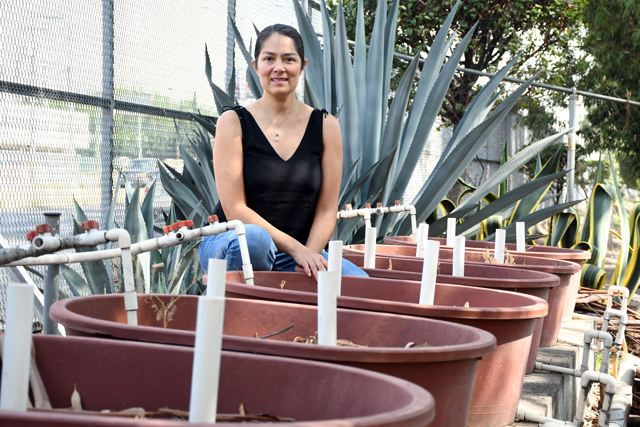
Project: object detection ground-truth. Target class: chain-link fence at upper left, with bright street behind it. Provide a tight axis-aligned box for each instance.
[0,0,321,328]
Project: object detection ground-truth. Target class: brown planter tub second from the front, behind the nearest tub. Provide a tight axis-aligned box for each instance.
[51,295,496,427]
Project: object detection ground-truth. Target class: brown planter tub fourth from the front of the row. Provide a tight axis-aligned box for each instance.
[344,251,556,373]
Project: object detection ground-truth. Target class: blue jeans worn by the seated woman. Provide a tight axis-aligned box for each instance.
[198,224,368,277]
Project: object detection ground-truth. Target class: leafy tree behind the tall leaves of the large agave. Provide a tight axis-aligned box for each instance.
[332,0,585,138]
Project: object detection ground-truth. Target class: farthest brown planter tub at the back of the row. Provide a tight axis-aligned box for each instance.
[384,236,591,322]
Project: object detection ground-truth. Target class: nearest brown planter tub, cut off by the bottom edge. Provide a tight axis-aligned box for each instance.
[0,335,435,427]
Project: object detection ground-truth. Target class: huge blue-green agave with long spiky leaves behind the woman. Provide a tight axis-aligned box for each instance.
[165,0,576,247]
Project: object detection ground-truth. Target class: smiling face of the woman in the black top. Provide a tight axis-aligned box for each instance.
[253,34,307,95]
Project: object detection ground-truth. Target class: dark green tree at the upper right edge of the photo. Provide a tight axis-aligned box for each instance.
[580,0,640,188]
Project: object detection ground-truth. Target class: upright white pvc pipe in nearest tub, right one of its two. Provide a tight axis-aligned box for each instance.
[189,295,224,423]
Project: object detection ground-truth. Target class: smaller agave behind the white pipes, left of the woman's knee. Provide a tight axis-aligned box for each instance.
[61,173,203,296]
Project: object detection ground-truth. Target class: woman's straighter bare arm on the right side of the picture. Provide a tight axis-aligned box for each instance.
[306,115,342,254]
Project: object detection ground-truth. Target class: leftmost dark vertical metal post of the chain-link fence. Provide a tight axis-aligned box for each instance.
[100,0,115,224]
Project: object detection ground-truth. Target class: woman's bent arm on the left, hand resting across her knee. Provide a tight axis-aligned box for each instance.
[213,111,322,276]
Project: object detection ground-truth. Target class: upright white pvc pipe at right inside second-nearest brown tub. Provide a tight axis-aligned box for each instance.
[318,271,338,345]
